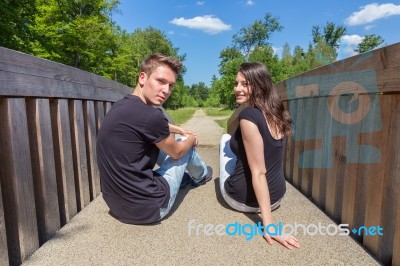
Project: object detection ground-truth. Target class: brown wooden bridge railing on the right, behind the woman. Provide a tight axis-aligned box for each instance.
[277,43,400,265]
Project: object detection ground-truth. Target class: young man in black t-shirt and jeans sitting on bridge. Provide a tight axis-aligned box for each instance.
[97,54,212,224]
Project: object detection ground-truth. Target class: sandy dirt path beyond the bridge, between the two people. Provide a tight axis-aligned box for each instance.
[181,109,224,147]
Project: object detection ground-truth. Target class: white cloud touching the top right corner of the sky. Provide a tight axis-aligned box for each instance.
[345,3,400,26]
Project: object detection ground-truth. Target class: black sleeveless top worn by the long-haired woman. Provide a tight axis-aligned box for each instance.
[224,107,286,207]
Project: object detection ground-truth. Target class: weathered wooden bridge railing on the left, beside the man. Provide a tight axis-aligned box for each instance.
[0,47,131,265]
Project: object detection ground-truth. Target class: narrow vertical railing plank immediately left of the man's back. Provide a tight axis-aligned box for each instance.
[83,101,100,200]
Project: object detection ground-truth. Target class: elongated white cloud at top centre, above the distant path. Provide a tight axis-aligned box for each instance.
[169,15,231,34]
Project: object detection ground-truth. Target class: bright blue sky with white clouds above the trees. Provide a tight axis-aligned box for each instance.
[113,0,400,86]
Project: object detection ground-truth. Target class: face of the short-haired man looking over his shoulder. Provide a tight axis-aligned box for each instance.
[139,65,176,105]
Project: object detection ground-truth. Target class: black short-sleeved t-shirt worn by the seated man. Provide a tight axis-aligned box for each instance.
[97,95,170,224]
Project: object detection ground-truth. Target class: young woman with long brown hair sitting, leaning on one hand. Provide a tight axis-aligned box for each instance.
[220,62,300,249]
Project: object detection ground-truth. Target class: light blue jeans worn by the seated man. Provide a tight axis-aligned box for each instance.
[155,138,207,220]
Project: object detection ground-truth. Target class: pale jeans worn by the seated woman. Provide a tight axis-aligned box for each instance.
[219,134,283,213]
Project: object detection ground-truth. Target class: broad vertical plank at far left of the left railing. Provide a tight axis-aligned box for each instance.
[0,98,39,265]
